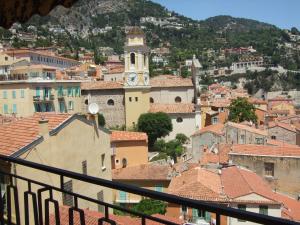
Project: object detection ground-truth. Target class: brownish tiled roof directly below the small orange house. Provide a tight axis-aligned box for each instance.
[112,164,170,180]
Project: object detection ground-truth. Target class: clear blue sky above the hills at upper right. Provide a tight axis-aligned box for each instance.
[153,0,300,29]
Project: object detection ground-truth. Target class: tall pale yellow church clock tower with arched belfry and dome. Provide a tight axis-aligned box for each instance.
[124,27,150,128]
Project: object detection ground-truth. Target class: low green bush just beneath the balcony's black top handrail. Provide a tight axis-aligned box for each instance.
[132,199,167,215]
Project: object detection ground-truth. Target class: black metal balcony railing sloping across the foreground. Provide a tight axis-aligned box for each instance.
[0,156,300,225]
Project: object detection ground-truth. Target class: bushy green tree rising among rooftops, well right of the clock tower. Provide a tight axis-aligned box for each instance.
[228,98,257,123]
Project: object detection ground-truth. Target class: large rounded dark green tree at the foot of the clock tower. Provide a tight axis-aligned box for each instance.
[137,112,173,148]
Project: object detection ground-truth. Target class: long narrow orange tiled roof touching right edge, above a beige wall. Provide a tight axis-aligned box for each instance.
[229,144,300,157]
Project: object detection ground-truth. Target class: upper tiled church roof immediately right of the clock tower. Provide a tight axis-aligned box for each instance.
[150,75,193,87]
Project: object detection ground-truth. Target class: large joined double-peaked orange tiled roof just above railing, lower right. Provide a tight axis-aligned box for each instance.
[168,166,300,221]
